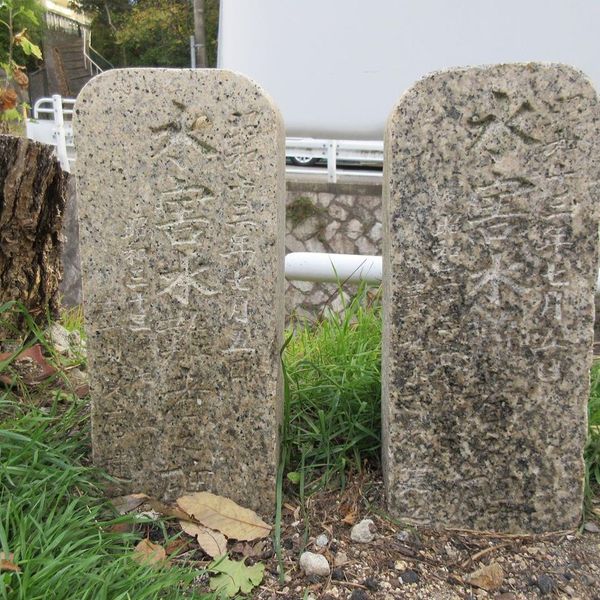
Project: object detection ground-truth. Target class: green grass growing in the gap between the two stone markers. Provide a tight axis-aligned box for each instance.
[283,287,381,490]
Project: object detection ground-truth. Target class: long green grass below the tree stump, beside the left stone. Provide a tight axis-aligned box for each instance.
[0,305,216,600]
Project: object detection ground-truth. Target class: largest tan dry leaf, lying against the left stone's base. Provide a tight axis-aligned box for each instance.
[177,492,271,541]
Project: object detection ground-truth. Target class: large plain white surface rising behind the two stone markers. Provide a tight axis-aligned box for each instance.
[218,0,600,139]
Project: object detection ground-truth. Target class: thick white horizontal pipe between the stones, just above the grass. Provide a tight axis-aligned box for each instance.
[285,252,381,284]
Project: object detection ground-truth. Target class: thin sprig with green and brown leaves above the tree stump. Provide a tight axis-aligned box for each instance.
[0,0,42,122]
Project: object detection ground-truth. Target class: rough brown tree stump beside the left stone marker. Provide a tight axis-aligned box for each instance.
[0,135,67,339]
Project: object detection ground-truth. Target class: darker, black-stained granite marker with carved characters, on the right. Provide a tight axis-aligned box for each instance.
[383,64,600,532]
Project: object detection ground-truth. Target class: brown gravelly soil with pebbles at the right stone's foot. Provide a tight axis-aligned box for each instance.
[246,476,600,600]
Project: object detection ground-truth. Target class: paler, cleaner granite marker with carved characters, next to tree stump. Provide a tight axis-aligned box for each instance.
[75,69,285,512]
